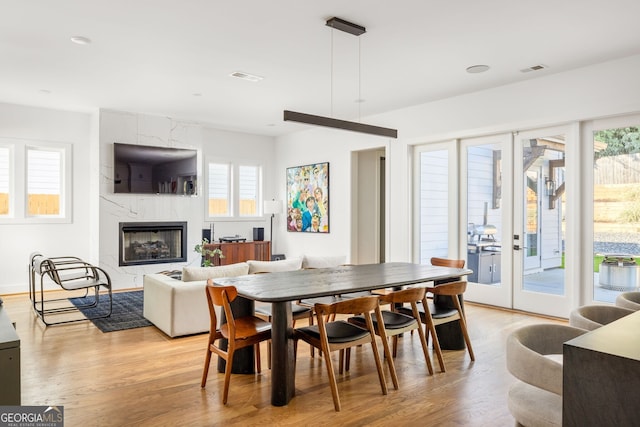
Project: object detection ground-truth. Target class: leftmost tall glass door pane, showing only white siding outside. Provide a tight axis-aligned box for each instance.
[420,150,449,264]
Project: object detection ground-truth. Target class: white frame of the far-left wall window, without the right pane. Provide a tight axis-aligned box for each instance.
[0,138,73,224]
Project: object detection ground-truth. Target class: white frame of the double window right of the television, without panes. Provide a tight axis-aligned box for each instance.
[203,157,264,221]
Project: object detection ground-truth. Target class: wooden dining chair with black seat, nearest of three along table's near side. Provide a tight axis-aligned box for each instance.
[293,296,395,411]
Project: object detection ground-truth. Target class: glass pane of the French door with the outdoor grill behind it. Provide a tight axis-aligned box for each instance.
[467,144,502,285]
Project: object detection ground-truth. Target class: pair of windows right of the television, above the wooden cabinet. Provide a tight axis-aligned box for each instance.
[207,162,262,218]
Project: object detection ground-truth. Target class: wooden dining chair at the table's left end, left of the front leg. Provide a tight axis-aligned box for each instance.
[201,279,271,404]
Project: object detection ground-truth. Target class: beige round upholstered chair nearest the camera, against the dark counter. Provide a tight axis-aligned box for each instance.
[507,324,587,427]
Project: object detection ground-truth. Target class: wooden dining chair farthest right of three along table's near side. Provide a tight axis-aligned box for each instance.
[398,281,476,372]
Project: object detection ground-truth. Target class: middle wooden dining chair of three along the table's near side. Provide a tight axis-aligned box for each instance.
[346,287,433,378]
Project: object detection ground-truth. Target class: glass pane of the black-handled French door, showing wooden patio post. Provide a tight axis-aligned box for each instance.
[519,135,566,295]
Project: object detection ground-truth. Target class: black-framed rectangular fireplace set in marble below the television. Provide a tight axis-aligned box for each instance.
[119,222,187,266]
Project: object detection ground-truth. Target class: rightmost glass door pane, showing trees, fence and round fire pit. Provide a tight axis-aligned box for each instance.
[593,127,640,303]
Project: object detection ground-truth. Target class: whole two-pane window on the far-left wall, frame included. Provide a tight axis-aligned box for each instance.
[0,139,71,223]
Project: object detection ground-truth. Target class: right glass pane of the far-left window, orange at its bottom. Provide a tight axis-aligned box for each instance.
[27,148,63,216]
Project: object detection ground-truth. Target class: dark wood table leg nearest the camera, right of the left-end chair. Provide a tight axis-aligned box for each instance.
[271,301,296,406]
